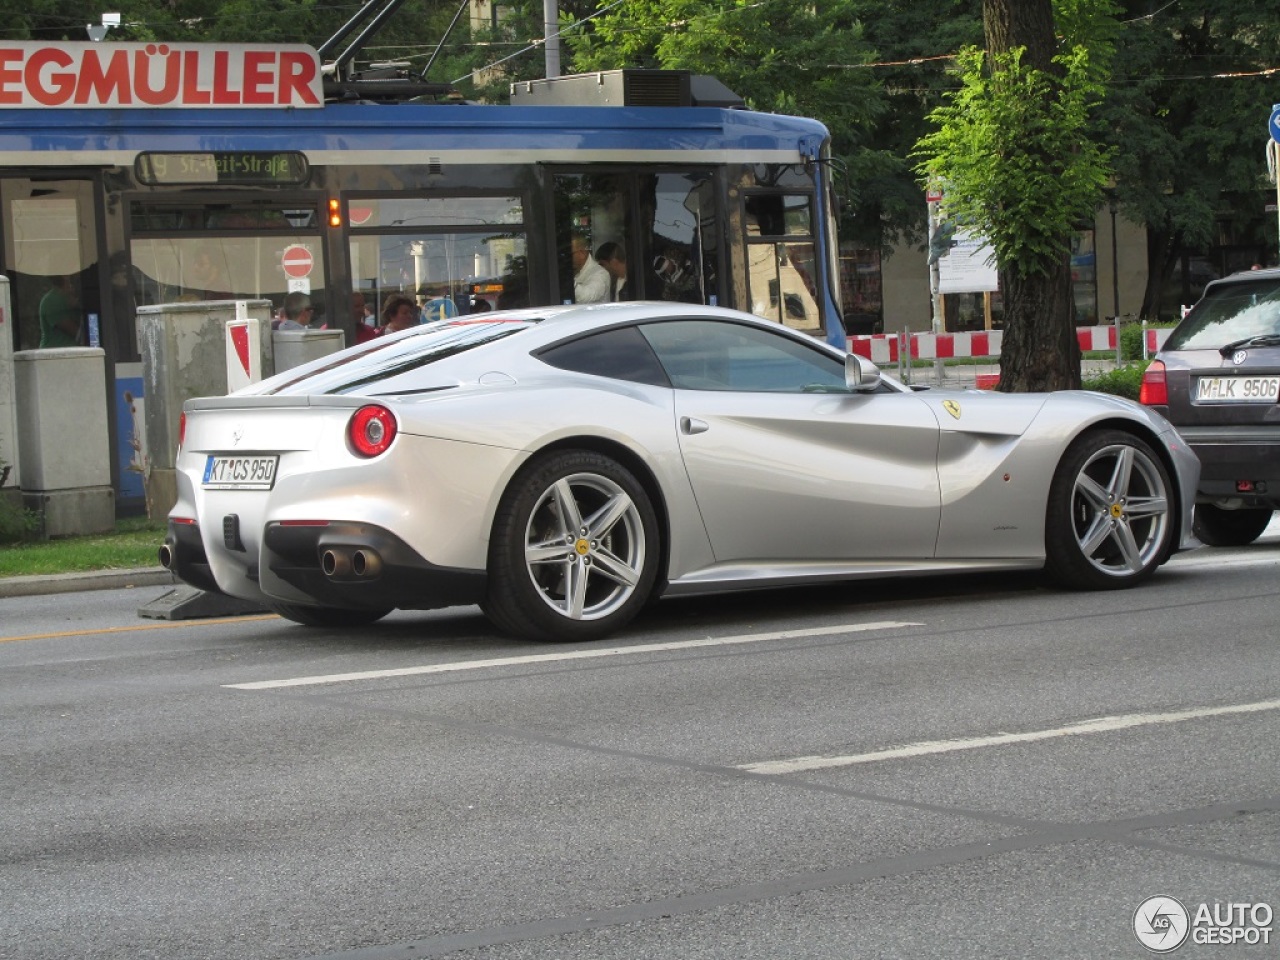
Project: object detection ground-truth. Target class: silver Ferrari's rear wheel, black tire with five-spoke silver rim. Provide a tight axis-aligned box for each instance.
[480,451,660,643]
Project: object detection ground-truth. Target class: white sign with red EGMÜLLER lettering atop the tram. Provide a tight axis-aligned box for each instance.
[0,41,324,110]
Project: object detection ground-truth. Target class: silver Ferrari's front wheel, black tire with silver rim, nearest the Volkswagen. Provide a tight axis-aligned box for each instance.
[1044,430,1178,590]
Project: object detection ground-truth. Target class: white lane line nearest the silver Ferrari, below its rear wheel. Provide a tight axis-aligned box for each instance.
[223,620,924,690]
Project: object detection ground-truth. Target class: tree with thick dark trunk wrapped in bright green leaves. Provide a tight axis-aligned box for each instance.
[919,0,1110,392]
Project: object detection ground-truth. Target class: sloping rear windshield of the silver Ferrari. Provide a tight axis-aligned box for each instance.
[262,316,538,396]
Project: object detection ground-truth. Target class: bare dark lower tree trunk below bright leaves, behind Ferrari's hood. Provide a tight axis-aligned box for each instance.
[997,255,1080,393]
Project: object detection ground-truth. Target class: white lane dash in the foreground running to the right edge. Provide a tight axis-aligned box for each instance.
[737,700,1280,773]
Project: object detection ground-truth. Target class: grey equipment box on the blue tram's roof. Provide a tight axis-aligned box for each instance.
[511,69,744,108]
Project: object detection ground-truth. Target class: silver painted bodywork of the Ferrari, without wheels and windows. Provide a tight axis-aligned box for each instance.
[170,303,1198,603]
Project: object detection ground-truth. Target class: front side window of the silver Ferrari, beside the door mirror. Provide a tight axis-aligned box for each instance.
[640,320,846,393]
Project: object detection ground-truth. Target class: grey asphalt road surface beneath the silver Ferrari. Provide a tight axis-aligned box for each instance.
[0,534,1280,960]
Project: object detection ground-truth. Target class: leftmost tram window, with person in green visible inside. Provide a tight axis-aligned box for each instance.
[0,177,102,349]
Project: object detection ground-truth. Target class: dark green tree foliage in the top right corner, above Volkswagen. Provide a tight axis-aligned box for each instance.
[1100,0,1280,319]
